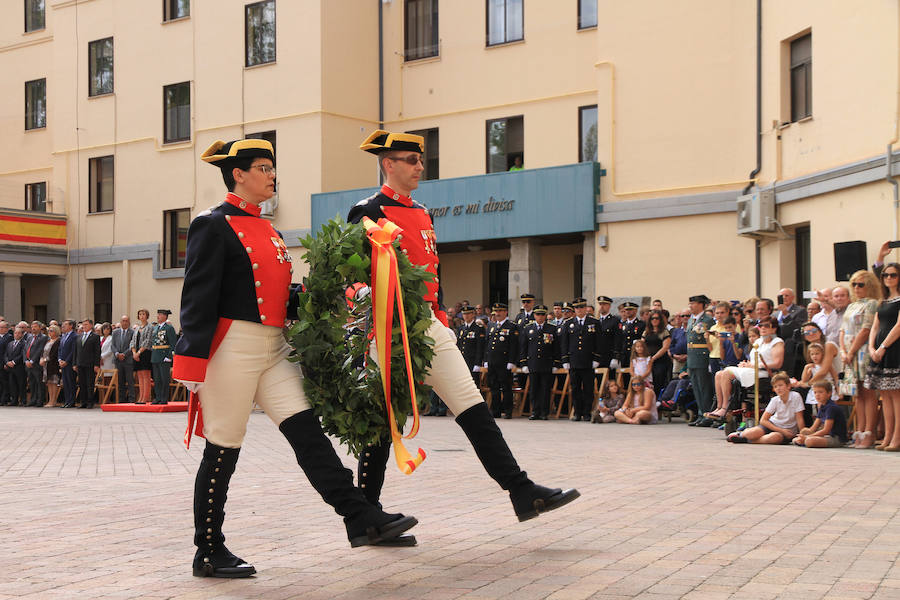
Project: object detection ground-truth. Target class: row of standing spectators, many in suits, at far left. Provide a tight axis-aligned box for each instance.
[0,309,176,409]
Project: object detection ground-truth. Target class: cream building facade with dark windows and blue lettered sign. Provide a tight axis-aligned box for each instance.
[0,0,900,328]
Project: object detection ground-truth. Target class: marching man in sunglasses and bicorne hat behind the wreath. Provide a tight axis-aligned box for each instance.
[347,130,580,521]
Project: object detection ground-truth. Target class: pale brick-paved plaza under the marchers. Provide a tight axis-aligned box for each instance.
[0,408,900,600]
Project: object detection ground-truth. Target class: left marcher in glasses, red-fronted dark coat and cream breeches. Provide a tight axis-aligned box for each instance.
[173,139,417,577]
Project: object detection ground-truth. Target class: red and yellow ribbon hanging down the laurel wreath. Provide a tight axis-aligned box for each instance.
[363,217,425,475]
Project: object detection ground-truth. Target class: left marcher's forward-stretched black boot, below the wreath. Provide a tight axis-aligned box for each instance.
[279,409,418,548]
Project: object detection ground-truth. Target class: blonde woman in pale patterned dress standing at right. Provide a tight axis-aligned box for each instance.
[833,270,881,448]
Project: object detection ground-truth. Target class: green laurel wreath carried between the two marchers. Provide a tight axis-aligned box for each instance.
[287,218,434,457]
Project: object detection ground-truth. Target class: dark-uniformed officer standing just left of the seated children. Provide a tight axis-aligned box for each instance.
[560,298,600,423]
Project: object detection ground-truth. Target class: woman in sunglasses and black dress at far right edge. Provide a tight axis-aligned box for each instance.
[866,263,900,452]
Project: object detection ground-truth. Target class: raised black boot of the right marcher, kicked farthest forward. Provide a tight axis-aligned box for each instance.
[456,402,581,521]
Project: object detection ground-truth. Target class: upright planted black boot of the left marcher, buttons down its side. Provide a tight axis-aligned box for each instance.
[194,442,256,577]
